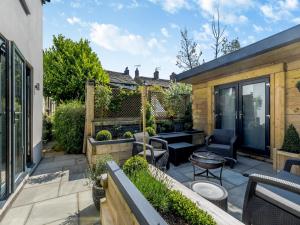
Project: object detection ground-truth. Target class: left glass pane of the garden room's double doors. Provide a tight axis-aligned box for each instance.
[216,87,237,130]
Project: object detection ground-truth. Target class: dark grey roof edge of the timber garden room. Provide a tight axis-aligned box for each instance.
[176,25,300,81]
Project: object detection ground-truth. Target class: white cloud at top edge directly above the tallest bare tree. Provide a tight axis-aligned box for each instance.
[197,0,254,24]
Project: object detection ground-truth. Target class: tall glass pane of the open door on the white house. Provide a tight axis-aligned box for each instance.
[13,51,24,180]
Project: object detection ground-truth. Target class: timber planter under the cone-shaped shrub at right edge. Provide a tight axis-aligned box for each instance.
[273,148,300,175]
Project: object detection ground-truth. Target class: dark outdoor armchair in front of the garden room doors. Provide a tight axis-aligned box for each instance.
[205,129,237,167]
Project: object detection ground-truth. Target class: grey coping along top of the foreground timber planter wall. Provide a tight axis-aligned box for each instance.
[107,161,167,225]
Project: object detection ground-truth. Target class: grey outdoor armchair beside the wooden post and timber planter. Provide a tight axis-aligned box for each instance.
[132,132,169,170]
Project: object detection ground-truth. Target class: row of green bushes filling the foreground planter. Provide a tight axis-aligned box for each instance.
[123,156,216,225]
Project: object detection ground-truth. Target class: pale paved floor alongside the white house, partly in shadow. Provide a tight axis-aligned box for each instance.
[0,153,99,225]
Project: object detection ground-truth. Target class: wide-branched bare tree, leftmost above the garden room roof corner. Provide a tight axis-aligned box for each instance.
[176,28,202,70]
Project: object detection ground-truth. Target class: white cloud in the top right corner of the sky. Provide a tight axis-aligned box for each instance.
[260,0,299,22]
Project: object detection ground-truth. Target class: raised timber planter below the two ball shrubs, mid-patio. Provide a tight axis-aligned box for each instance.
[86,137,134,166]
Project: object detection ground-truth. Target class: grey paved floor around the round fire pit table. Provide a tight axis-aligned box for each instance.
[168,156,276,220]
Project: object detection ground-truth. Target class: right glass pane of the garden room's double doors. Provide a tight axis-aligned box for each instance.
[240,82,267,150]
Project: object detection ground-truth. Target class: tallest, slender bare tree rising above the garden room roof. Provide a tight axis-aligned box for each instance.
[211,7,226,59]
